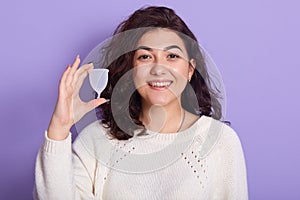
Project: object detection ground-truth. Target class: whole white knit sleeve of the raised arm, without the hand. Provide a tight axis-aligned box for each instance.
[34,134,96,200]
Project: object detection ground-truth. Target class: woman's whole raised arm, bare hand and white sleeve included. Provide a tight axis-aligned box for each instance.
[34,56,105,199]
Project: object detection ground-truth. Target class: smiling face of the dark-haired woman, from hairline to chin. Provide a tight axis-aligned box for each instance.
[133,28,195,106]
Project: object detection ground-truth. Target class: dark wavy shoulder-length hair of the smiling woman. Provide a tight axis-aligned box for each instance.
[96,6,222,140]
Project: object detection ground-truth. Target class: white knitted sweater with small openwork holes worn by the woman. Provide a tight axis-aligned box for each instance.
[34,116,248,200]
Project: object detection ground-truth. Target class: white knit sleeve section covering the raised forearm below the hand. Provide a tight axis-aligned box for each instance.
[34,132,78,199]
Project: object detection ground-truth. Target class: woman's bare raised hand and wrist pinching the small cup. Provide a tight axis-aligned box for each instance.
[47,55,106,140]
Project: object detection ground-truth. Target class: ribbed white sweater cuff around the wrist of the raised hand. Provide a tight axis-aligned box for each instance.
[42,131,72,154]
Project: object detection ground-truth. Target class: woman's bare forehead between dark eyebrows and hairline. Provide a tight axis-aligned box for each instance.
[137,28,185,51]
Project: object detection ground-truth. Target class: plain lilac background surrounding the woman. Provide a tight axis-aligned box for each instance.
[0,0,300,200]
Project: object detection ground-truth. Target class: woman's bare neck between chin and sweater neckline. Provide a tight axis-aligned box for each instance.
[141,101,185,133]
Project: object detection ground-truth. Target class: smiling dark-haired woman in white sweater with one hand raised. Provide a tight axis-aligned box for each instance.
[35,7,248,200]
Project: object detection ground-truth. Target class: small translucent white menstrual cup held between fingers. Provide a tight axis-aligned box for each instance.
[89,69,108,98]
